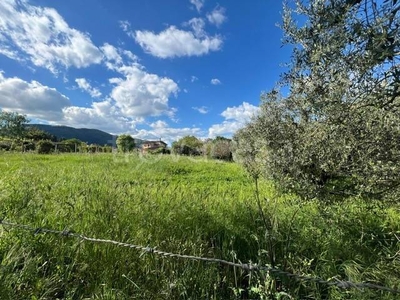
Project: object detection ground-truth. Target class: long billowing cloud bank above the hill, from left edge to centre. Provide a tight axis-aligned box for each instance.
[0,35,179,133]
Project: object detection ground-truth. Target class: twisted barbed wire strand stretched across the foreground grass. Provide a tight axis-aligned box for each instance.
[0,219,400,294]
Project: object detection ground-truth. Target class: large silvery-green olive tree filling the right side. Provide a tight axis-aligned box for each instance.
[235,0,400,197]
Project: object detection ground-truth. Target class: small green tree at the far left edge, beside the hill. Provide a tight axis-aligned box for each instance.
[0,111,29,139]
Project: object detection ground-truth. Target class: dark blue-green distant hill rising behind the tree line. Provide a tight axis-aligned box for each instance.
[28,124,117,145]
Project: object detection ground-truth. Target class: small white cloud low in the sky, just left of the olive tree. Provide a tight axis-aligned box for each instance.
[208,102,259,138]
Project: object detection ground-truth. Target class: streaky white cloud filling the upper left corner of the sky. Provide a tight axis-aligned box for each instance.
[0,0,102,73]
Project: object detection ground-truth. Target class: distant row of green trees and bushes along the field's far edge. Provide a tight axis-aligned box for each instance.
[0,111,232,161]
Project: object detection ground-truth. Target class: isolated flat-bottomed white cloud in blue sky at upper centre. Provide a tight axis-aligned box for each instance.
[133,26,223,58]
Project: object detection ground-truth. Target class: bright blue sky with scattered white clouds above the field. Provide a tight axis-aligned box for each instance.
[0,0,290,143]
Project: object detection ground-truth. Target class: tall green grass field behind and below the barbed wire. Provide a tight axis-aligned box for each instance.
[0,153,400,299]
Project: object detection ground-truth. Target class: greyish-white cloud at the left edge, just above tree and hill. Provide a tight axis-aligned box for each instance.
[0,73,71,120]
